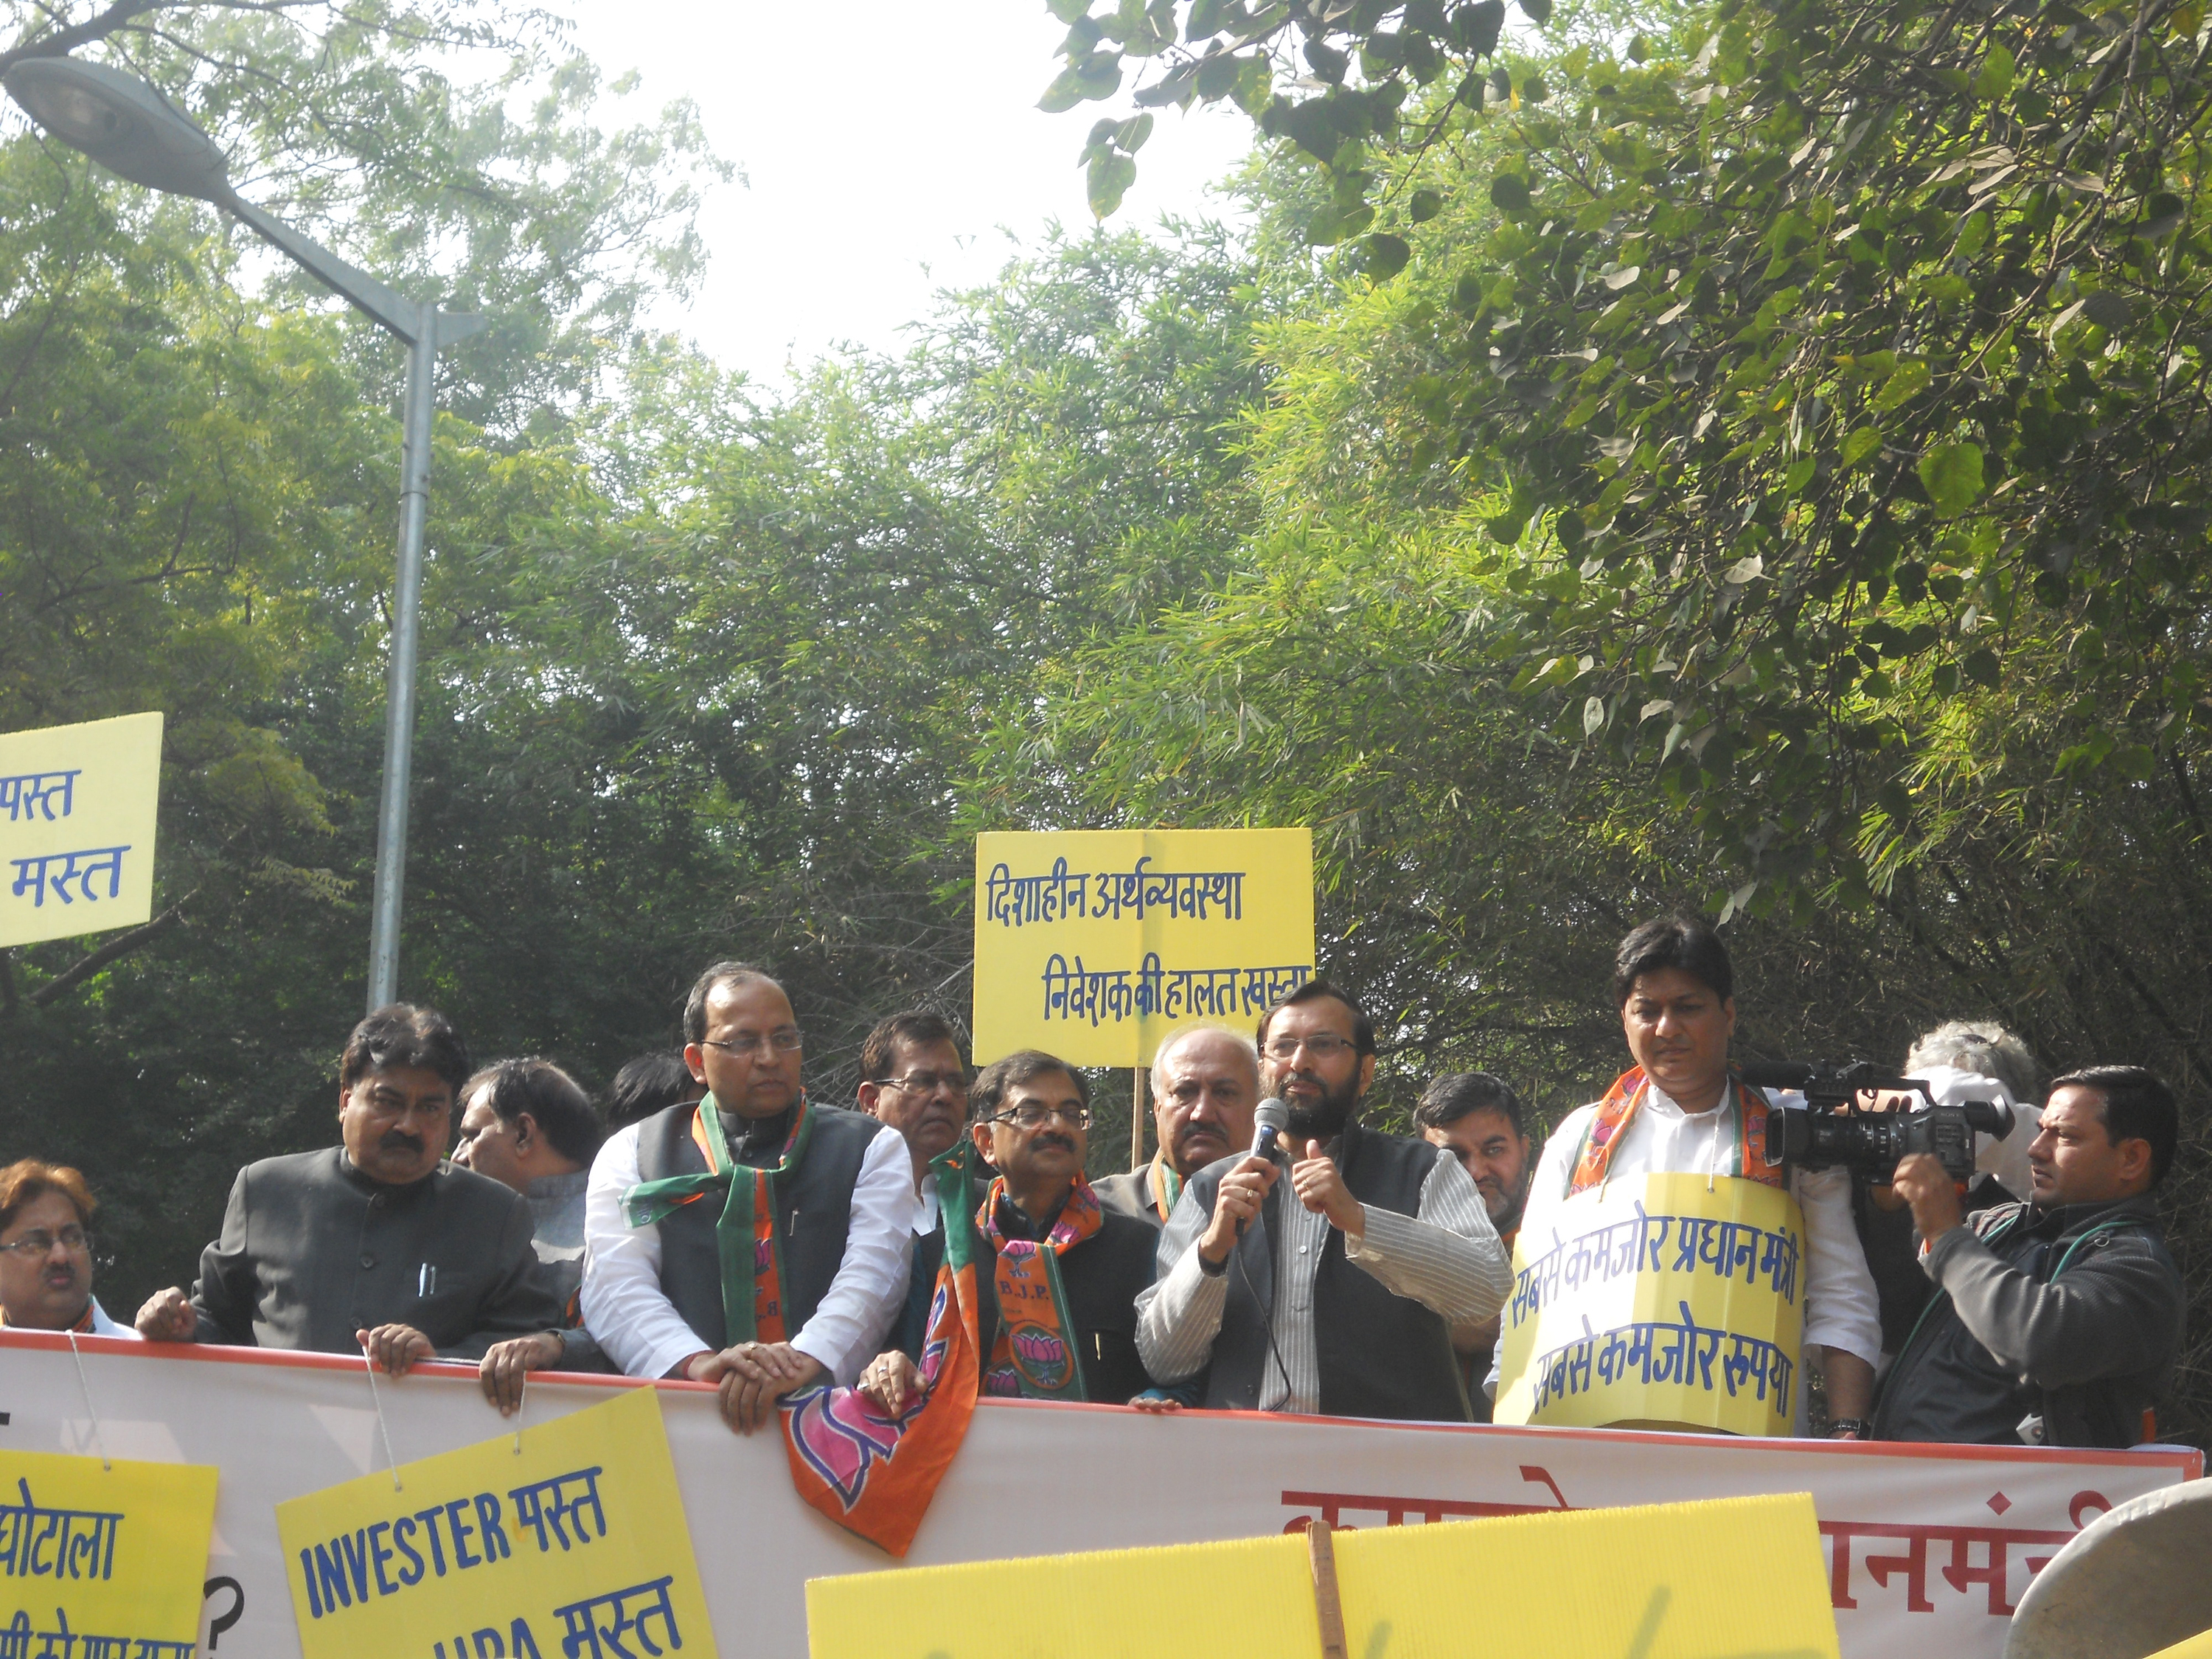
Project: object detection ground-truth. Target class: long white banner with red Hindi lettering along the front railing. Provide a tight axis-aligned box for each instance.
[0,1329,2203,1659]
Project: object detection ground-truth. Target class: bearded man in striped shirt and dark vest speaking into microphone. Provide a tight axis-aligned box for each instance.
[1137,980,1513,1422]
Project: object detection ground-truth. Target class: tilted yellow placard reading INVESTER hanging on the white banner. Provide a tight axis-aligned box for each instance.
[276,1389,714,1659]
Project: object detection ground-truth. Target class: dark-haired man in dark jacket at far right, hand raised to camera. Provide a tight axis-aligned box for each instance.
[1874,1066,2183,1447]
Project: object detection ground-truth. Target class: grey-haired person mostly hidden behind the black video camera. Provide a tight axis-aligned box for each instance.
[1851,1020,2035,1367]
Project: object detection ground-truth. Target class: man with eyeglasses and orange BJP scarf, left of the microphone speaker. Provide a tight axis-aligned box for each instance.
[860,1048,1155,1418]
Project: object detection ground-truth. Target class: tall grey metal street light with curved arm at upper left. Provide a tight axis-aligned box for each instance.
[4,58,489,1009]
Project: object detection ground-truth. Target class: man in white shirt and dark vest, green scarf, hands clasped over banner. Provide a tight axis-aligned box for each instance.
[584,962,914,1433]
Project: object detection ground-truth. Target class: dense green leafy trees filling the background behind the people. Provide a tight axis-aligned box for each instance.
[0,0,2212,1438]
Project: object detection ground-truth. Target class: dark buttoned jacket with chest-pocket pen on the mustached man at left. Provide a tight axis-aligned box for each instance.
[192,1146,562,1360]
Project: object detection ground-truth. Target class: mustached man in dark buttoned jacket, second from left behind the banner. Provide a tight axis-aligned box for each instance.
[137,1002,562,1376]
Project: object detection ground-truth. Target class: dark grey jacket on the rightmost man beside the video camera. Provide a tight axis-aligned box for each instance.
[1874,1194,2185,1447]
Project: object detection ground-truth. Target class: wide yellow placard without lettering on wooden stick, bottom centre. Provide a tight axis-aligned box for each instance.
[807,1493,1836,1659]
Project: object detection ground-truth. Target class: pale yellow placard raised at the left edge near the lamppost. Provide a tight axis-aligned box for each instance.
[0,714,161,947]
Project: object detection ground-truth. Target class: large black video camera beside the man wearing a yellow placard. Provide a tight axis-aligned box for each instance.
[1743,1060,2013,1186]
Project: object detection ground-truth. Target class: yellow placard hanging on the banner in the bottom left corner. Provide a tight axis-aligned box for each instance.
[0,1451,217,1659]
